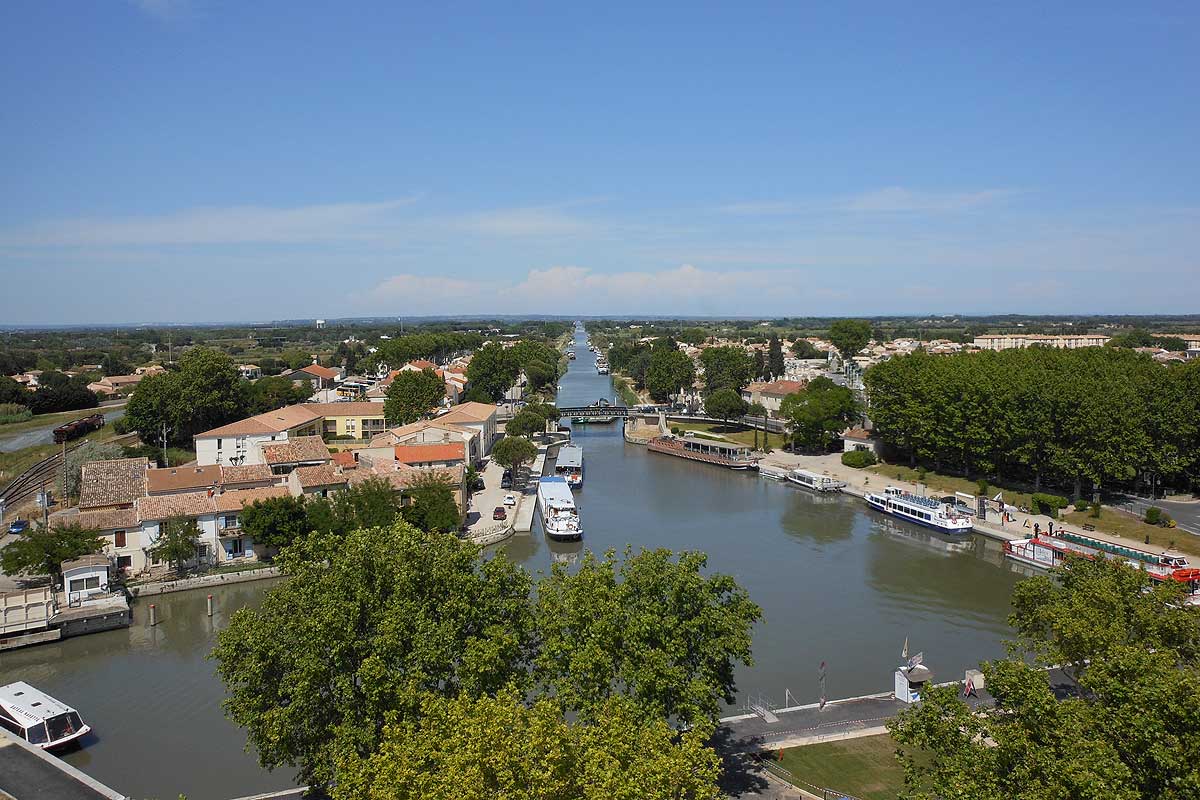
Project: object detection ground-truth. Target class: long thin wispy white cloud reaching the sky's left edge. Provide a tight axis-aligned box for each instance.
[0,198,413,247]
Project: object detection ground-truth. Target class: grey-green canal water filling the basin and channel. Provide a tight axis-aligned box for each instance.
[0,333,1021,800]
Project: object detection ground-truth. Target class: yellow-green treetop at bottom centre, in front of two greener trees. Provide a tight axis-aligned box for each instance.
[334,690,721,800]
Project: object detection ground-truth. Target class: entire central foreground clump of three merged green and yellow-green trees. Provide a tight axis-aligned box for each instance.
[214,521,761,800]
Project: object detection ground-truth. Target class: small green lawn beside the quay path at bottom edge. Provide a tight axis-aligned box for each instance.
[780,734,904,800]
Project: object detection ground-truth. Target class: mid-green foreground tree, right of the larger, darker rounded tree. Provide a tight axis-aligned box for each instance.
[534,549,762,722]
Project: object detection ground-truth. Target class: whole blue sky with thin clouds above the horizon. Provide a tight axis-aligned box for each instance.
[0,0,1200,324]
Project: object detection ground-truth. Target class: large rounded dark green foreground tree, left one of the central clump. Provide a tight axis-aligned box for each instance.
[214,521,533,787]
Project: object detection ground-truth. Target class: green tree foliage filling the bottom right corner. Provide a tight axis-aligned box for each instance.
[889,558,1200,800]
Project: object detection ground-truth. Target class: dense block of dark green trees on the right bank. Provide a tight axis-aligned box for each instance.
[864,348,1200,497]
